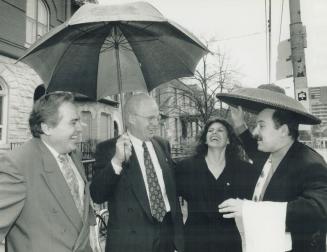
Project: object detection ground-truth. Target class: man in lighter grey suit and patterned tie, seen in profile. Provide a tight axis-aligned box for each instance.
[0,92,95,252]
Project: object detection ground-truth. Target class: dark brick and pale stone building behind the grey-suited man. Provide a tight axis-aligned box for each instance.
[0,0,122,152]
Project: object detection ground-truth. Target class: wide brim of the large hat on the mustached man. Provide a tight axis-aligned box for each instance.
[216,88,321,125]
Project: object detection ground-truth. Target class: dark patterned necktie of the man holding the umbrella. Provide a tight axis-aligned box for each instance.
[142,142,166,222]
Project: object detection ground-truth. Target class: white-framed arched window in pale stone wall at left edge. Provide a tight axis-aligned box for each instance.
[0,78,8,144]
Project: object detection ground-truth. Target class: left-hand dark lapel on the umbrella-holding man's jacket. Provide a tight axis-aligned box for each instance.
[126,148,153,220]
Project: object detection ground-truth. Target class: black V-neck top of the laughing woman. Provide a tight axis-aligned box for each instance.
[176,156,256,252]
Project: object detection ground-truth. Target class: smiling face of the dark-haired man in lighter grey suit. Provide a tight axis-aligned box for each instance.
[42,102,82,154]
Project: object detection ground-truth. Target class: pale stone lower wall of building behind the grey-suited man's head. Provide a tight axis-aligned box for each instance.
[0,55,123,153]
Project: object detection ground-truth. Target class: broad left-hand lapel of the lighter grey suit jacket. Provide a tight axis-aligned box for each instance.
[38,140,83,230]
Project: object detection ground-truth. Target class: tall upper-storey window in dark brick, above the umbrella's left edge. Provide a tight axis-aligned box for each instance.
[26,0,49,47]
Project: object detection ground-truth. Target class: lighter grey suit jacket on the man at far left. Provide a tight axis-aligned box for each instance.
[0,138,95,252]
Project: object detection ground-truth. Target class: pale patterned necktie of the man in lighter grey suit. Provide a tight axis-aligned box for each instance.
[58,154,84,216]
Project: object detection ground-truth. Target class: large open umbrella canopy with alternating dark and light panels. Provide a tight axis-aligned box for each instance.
[19,2,208,100]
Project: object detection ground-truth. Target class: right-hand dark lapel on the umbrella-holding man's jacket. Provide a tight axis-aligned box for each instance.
[151,139,176,218]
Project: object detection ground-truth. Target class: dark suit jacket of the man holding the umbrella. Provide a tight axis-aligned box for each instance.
[91,138,183,252]
